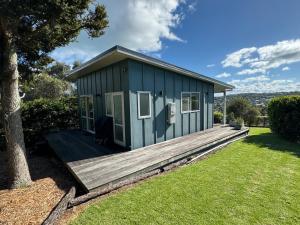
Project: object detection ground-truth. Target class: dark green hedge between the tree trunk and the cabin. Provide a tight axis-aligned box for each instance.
[21,97,79,147]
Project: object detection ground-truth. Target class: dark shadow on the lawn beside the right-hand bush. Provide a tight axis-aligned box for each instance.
[243,133,300,157]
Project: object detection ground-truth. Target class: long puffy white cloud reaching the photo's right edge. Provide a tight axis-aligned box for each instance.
[222,39,300,74]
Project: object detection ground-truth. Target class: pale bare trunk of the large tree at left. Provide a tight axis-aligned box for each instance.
[0,23,31,188]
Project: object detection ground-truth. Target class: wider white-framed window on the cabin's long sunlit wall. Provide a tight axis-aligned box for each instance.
[181,92,200,113]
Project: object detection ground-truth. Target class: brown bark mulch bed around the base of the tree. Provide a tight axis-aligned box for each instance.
[0,151,75,225]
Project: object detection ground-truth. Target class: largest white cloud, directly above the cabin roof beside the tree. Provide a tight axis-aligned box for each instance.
[51,0,188,61]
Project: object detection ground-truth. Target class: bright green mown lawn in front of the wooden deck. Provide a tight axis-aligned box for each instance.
[72,128,300,225]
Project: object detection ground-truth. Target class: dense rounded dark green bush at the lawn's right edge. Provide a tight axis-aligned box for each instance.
[268,95,300,141]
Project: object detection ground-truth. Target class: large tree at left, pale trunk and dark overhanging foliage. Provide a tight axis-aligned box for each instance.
[0,0,108,187]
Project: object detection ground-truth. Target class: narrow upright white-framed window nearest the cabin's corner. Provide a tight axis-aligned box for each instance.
[138,91,151,119]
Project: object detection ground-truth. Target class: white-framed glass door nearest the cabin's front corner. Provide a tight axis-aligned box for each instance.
[112,92,126,146]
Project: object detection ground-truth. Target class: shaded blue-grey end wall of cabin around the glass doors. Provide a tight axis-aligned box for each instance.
[76,60,131,148]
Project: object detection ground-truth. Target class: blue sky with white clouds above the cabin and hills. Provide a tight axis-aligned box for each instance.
[51,0,300,93]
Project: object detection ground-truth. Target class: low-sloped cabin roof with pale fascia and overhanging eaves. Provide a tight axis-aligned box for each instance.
[67,45,234,92]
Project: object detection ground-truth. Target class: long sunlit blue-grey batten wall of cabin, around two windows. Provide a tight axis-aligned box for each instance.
[128,60,214,149]
